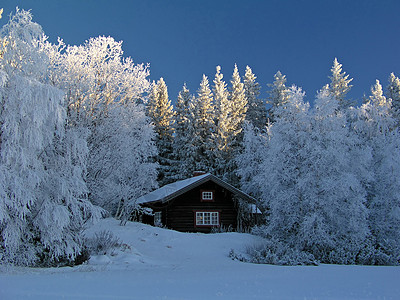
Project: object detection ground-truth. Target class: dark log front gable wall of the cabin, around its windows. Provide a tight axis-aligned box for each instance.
[154,181,237,233]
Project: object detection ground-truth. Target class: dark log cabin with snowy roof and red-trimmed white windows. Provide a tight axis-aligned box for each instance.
[137,173,261,233]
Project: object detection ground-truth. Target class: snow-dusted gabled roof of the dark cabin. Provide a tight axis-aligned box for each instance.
[136,173,255,204]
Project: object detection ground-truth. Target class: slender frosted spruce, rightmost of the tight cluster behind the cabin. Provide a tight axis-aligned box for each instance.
[243,66,267,129]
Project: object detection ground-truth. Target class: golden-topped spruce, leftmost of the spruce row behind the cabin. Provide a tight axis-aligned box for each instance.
[147,78,176,186]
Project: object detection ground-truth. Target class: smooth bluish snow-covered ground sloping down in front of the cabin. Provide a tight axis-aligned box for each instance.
[0,219,400,300]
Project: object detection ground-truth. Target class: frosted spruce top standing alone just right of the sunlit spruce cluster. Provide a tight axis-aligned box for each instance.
[267,71,289,122]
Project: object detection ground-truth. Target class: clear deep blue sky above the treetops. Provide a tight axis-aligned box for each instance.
[0,0,400,105]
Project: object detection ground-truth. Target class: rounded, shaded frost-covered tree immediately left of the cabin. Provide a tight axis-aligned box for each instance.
[88,103,158,218]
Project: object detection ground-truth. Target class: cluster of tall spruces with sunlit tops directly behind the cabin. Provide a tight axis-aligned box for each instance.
[147,65,267,185]
